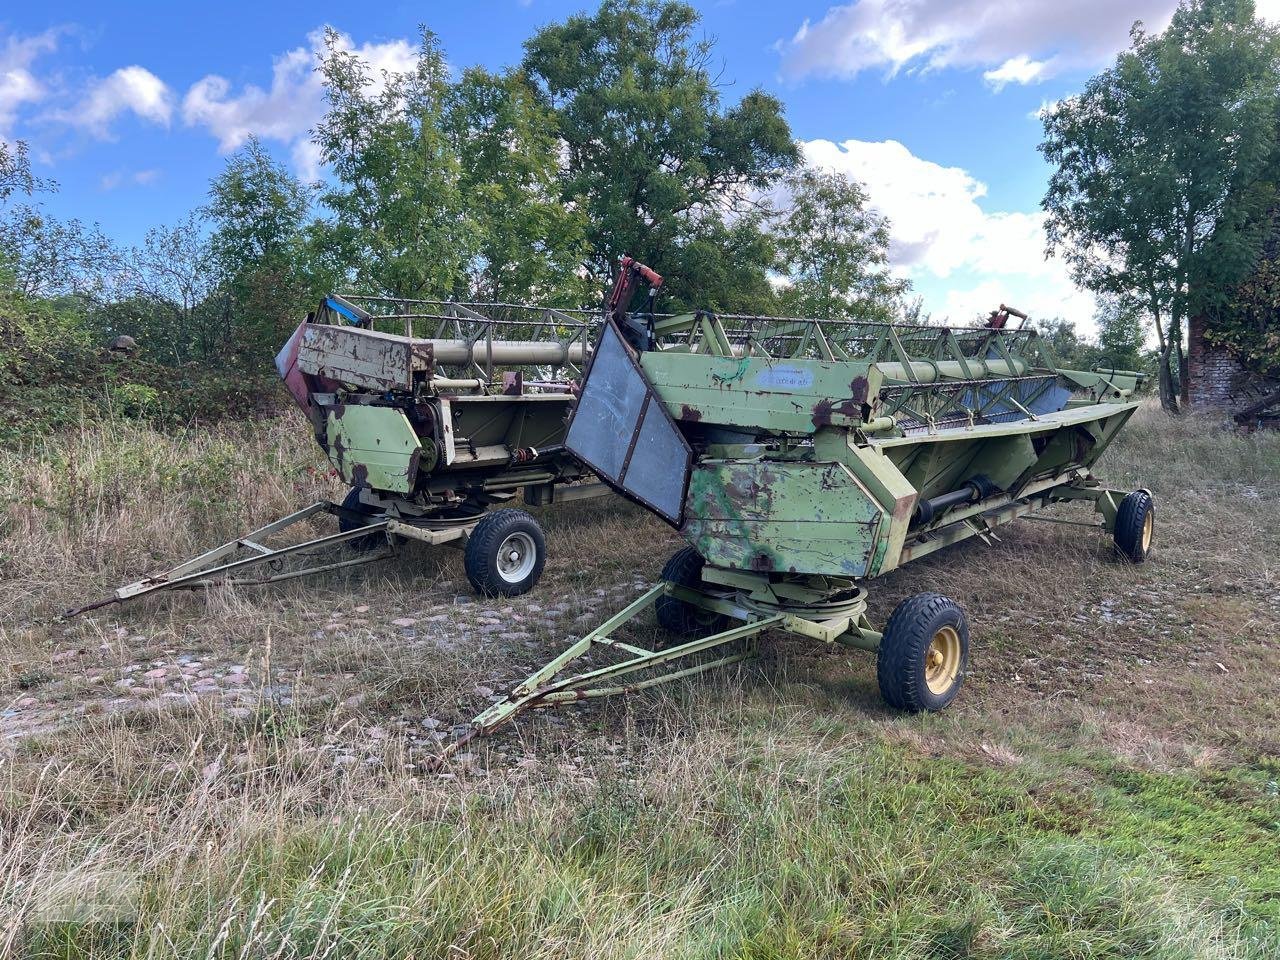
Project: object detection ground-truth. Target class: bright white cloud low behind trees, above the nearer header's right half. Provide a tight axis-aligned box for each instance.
[801,140,1093,329]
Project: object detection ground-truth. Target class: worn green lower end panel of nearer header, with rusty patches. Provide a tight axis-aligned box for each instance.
[681,461,883,576]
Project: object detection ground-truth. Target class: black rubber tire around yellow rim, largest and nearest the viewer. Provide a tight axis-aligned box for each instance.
[876,593,969,713]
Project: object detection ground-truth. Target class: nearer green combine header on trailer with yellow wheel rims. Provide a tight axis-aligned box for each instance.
[440,259,1155,759]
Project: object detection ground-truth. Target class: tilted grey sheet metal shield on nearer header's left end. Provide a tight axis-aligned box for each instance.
[564,320,692,526]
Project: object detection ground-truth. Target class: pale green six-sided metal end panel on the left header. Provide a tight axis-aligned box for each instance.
[325,403,422,493]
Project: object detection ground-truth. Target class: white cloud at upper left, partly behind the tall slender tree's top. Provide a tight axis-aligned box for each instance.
[182,31,417,178]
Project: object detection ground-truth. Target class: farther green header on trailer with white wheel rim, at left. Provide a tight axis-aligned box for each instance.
[65,296,611,616]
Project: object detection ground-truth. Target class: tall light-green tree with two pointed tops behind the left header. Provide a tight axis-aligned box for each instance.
[312,29,477,298]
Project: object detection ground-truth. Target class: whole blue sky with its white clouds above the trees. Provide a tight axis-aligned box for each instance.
[0,0,1239,328]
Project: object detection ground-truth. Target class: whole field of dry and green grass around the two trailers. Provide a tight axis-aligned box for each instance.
[0,401,1280,960]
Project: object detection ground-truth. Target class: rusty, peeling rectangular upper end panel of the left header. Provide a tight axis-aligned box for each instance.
[297,324,433,390]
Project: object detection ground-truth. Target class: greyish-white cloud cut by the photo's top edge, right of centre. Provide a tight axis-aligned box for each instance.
[780,0,1172,88]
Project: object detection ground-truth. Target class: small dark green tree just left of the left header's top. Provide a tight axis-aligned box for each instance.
[205,138,317,355]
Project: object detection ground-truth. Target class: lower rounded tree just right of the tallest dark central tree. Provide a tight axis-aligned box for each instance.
[773,166,910,321]
